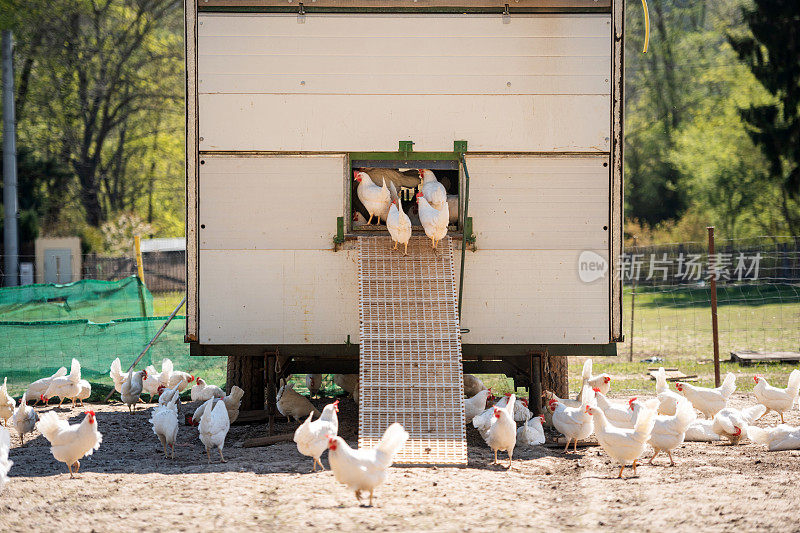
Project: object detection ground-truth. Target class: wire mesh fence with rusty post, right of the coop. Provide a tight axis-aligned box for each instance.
[617,237,800,359]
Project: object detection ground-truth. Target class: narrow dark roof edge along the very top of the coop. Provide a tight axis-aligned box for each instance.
[196,0,612,14]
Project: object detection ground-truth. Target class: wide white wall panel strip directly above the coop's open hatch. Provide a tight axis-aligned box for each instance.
[199,94,610,152]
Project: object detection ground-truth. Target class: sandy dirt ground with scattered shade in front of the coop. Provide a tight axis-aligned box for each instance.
[0,395,800,532]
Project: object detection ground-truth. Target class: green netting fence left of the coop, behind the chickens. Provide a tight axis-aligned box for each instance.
[0,276,225,395]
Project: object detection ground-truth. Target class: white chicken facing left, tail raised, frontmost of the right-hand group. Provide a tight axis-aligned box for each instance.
[586,405,656,478]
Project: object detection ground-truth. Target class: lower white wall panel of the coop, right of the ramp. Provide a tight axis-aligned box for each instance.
[456,249,609,344]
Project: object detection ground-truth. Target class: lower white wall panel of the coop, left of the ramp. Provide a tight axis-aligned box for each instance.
[200,250,358,344]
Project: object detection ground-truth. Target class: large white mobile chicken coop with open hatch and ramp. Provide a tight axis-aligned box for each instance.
[186,0,624,462]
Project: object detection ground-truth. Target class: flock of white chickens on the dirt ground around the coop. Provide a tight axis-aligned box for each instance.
[0,359,800,505]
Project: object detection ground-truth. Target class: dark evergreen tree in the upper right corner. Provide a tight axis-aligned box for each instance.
[727,0,800,235]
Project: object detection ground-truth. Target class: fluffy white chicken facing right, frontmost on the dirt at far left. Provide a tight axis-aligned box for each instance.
[36,411,103,478]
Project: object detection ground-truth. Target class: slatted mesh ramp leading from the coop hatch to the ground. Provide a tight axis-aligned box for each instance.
[358,236,467,464]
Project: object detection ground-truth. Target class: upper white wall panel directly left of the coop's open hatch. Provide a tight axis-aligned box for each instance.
[199,155,345,250]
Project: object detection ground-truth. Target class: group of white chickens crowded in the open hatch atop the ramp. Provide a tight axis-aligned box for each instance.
[353,169,450,255]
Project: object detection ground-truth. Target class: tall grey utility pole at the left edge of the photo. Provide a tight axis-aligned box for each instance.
[2,30,19,287]
